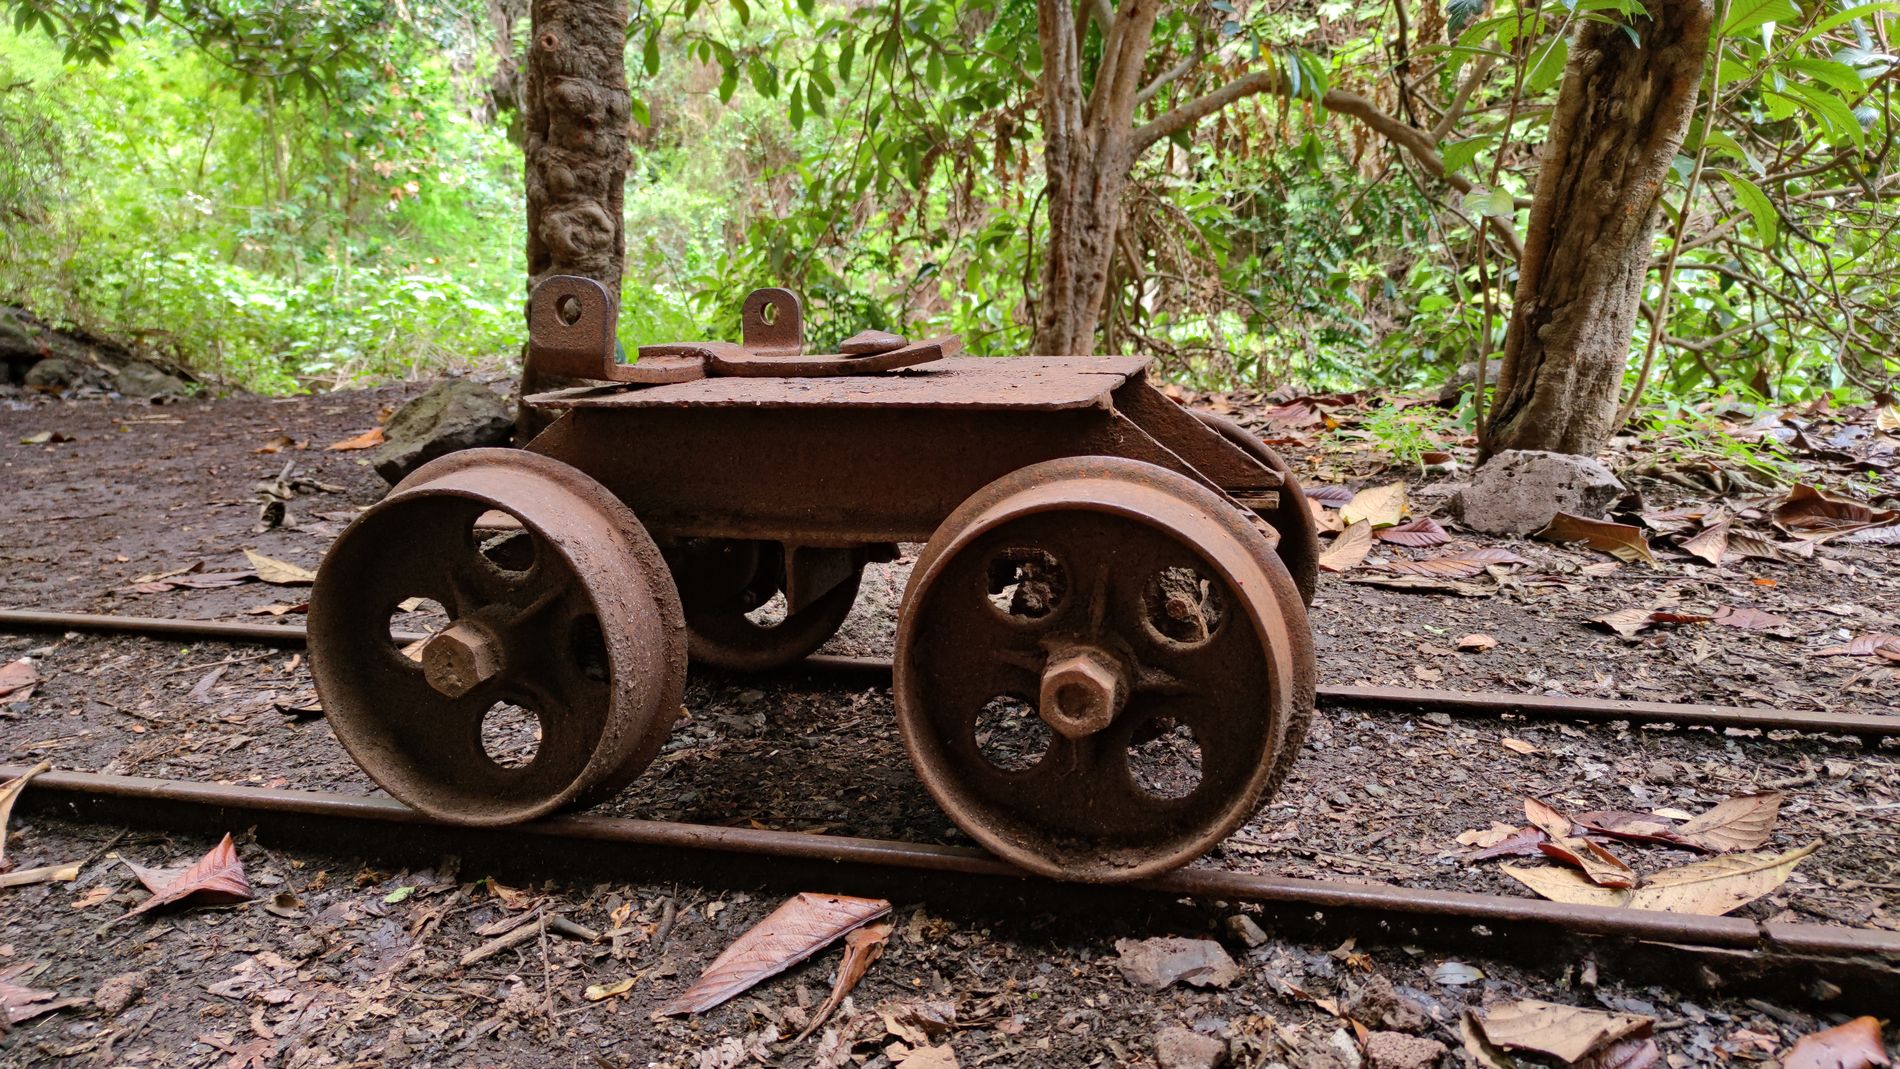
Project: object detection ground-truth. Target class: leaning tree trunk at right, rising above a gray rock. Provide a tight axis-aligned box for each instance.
[1484,0,1712,456]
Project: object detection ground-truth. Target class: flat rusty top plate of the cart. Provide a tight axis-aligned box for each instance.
[528,357,1148,408]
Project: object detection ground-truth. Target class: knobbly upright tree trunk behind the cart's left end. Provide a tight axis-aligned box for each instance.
[515,0,629,441]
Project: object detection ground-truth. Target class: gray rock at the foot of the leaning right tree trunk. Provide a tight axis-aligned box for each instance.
[1452,450,1623,535]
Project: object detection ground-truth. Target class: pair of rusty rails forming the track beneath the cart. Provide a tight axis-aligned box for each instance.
[0,610,1900,1008]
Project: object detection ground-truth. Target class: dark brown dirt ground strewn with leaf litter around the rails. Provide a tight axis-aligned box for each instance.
[0,375,1900,1069]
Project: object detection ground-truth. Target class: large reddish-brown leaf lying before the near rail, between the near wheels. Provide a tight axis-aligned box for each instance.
[659,891,891,1016]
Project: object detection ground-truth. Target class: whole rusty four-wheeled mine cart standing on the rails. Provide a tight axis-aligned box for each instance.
[310,277,1317,883]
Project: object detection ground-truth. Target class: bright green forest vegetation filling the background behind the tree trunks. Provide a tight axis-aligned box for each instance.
[0,0,1900,403]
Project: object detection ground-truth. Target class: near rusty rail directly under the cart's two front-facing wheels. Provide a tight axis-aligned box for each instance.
[14,765,1900,968]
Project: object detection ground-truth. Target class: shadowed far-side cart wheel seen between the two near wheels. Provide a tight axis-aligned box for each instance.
[667,539,863,672]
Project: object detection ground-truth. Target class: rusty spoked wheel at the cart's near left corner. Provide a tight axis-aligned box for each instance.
[310,450,686,824]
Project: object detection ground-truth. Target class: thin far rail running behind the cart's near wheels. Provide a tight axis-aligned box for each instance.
[0,610,1900,739]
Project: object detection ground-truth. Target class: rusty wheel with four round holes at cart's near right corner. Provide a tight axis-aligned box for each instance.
[895,458,1313,883]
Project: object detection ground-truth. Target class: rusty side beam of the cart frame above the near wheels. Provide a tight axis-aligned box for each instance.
[530,406,1246,545]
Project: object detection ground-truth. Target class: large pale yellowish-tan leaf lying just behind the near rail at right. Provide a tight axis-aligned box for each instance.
[1503,843,1820,917]
